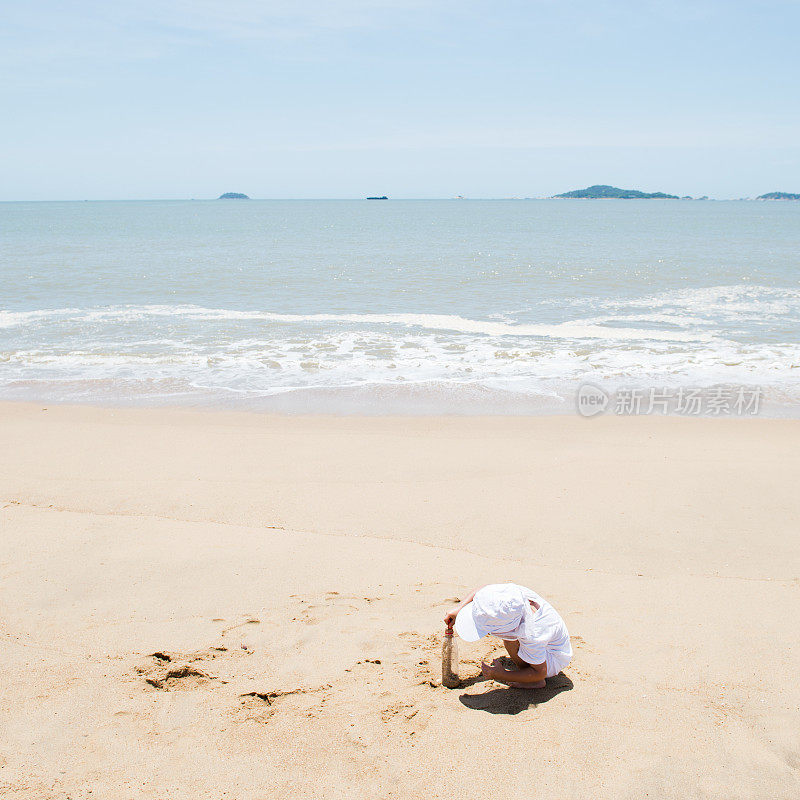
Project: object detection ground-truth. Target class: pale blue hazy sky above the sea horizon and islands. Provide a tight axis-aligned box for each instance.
[0,0,800,200]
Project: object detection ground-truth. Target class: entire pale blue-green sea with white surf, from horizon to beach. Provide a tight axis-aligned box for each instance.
[0,200,800,416]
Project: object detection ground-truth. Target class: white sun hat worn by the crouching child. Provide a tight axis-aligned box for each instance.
[455,583,531,642]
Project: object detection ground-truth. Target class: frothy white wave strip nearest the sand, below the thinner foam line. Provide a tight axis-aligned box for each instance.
[0,332,800,390]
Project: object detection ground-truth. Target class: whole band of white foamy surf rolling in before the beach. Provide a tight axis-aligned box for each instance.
[0,285,800,406]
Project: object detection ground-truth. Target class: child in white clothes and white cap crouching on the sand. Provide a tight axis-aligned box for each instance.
[444,583,572,689]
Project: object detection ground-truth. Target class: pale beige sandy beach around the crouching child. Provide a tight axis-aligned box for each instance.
[0,404,800,800]
